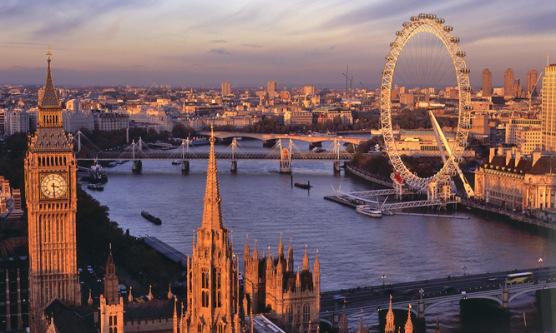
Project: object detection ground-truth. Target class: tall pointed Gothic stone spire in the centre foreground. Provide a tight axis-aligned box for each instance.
[180,127,242,333]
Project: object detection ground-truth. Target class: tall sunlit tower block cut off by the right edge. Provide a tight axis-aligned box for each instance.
[541,64,556,152]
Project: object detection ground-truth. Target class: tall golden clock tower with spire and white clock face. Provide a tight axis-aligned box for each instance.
[25,52,81,333]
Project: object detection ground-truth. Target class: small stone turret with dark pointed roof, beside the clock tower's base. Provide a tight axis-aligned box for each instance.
[99,248,124,333]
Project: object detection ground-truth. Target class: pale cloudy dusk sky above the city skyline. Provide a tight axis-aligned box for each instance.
[0,0,556,87]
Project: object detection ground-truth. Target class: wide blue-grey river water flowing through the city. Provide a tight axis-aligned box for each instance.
[86,141,556,332]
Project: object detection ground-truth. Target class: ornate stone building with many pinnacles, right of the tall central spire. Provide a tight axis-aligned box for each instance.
[244,239,320,333]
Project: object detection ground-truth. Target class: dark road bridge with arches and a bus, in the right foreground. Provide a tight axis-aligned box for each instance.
[321,267,556,322]
